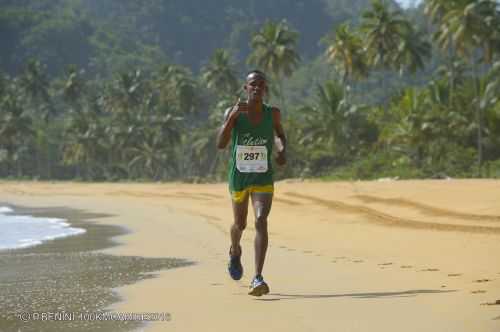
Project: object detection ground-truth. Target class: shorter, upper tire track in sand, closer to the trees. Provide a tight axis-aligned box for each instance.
[353,195,500,222]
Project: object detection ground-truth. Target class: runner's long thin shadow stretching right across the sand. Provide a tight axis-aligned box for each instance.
[256,289,456,301]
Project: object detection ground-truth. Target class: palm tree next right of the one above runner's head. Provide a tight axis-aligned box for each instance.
[324,24,368,96]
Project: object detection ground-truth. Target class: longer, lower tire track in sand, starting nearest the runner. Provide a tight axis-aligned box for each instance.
[285,192,500,234]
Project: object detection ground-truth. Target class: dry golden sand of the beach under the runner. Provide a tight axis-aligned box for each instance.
[0,180,500,332]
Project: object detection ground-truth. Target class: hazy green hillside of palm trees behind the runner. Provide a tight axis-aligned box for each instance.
[0,0,500,181]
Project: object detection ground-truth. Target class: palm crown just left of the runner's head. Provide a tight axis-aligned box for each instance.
[201,48,238,95]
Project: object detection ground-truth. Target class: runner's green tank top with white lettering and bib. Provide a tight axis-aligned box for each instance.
[229,104,274,191]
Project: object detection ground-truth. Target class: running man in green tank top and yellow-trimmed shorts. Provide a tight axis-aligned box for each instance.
[217,70,286,296]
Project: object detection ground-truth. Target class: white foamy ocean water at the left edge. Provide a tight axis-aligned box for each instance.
[0,206,85,250]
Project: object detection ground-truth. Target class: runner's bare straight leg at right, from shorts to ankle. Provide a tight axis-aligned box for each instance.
[251,193,273,276]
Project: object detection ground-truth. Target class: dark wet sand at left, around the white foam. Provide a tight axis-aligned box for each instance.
[0,204,189,331]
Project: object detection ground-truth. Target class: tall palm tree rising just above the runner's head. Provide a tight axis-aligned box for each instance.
[247,21,300,108]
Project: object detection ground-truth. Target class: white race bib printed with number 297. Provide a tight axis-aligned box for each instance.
[236,145,267,173]
